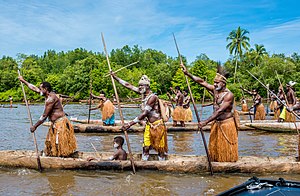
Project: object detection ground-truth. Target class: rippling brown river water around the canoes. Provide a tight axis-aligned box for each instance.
[0,104,300,195]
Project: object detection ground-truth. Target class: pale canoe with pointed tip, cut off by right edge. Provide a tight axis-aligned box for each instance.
[245,122,300,133]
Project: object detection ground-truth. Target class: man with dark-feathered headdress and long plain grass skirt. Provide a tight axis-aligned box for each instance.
[181,64,238,162]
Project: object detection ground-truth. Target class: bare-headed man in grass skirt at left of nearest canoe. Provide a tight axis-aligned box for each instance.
[19,76,77,157]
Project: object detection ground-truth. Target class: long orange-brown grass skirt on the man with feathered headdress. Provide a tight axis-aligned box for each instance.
[208,118,238,162]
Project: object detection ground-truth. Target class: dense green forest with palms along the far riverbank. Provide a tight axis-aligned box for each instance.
[0,27,300,102]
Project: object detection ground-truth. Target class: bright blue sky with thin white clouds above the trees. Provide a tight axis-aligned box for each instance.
[0,0,300,62]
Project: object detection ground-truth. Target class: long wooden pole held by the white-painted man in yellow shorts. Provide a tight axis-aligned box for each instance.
[101,33,135,174]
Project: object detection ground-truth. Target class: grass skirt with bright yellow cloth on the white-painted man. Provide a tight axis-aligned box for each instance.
[143,120,168,153]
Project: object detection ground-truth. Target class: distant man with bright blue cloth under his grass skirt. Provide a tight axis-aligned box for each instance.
[90,92,115,126]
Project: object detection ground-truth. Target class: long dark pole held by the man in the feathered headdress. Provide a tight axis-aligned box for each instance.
[173,33,213,175]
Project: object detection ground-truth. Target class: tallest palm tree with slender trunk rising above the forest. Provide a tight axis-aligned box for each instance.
[226,27,250,83]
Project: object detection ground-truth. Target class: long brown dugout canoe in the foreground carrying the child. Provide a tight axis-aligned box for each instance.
[0,150,300,174]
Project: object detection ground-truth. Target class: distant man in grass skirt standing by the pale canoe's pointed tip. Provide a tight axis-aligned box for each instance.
[242,88,266,120]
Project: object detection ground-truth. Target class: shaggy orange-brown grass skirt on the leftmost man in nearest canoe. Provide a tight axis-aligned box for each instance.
[44,116,77,157]
